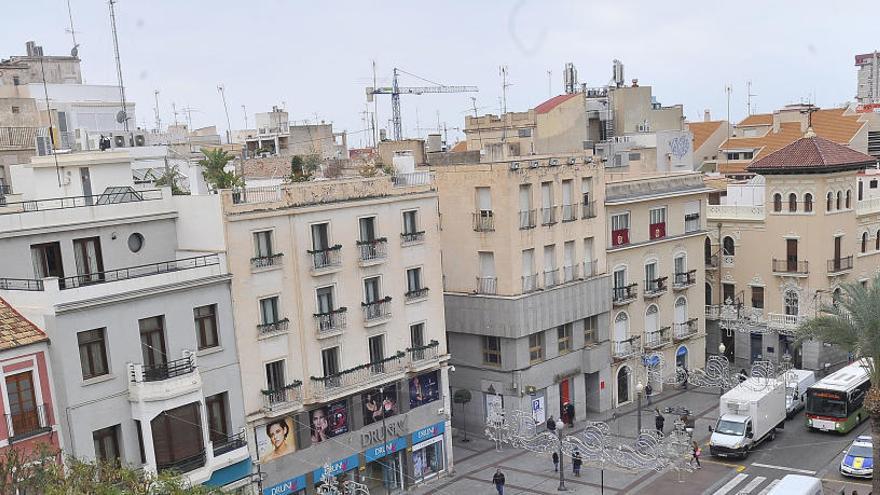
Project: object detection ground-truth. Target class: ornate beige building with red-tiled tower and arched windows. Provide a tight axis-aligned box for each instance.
[704,130,880,370]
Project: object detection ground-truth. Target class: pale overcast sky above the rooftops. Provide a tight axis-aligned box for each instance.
[0,0,880,147]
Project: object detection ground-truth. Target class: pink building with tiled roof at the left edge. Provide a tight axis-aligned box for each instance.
[0,298,61,462]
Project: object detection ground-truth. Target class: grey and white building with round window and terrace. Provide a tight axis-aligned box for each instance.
[0,151,251,487]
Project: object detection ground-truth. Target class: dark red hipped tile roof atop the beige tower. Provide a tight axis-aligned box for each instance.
[746,135,877,173]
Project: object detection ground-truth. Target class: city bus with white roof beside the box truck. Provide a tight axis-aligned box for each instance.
[806,359,871,433]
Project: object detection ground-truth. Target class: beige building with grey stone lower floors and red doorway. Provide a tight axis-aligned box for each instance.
[433,154,611,430]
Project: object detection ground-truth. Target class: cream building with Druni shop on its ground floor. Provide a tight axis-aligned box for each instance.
[221,173,452,494]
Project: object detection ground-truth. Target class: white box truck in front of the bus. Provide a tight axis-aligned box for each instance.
[709,378,785,457]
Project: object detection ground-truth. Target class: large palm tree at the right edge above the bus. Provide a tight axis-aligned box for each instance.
[798,275,880,493]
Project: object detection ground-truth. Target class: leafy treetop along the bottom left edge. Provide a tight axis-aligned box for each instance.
[0,445,219,495]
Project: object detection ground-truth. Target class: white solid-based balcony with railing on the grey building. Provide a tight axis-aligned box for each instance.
[128,351,202,402]
